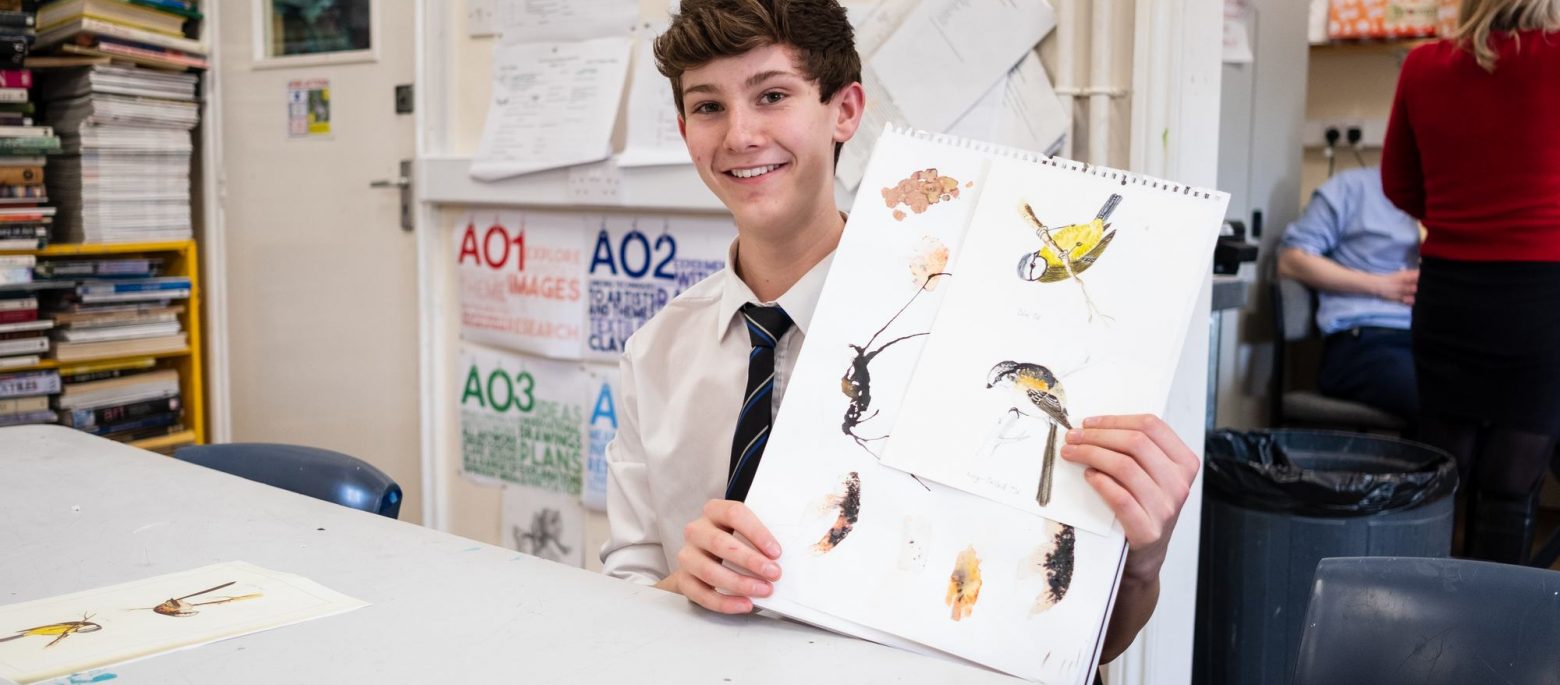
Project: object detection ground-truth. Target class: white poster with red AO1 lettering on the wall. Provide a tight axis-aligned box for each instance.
[451,211,590,359]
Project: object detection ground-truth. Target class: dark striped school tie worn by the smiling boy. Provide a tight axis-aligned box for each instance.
[725,303,791,501]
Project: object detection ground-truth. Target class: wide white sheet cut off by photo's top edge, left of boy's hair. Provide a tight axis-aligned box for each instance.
[493,0,640,44]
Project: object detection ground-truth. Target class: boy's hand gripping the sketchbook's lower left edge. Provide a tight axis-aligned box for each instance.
[663,499,780,613]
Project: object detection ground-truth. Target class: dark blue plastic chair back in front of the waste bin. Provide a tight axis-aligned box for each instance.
[1293,557,1560,685]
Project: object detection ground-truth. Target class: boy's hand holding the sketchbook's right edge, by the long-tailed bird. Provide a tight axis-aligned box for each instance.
[1062,413,1201,580]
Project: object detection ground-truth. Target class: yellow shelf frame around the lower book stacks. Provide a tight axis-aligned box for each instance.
[0,240,206,449]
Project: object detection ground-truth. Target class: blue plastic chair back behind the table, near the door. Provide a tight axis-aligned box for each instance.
[173,443,401,518]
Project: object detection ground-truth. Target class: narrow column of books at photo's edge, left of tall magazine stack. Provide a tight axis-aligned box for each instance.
[0,0,59,250]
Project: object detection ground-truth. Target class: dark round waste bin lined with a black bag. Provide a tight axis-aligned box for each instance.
[1192,431,1457,685]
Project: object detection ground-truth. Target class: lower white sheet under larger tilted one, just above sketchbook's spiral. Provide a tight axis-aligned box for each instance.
[948,50,1069,153]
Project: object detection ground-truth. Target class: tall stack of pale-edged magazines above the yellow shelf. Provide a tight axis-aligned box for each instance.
[37,64,200,242]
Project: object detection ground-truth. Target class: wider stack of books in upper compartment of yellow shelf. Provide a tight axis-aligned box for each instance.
[39,257,190,364]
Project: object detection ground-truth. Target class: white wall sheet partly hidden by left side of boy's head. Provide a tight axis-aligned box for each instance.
[618,34,693,167]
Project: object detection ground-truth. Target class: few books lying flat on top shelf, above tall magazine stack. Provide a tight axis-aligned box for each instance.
[37,0,206,70]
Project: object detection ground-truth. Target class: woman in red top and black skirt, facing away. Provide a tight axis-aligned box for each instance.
[1382,0,1560,563]
